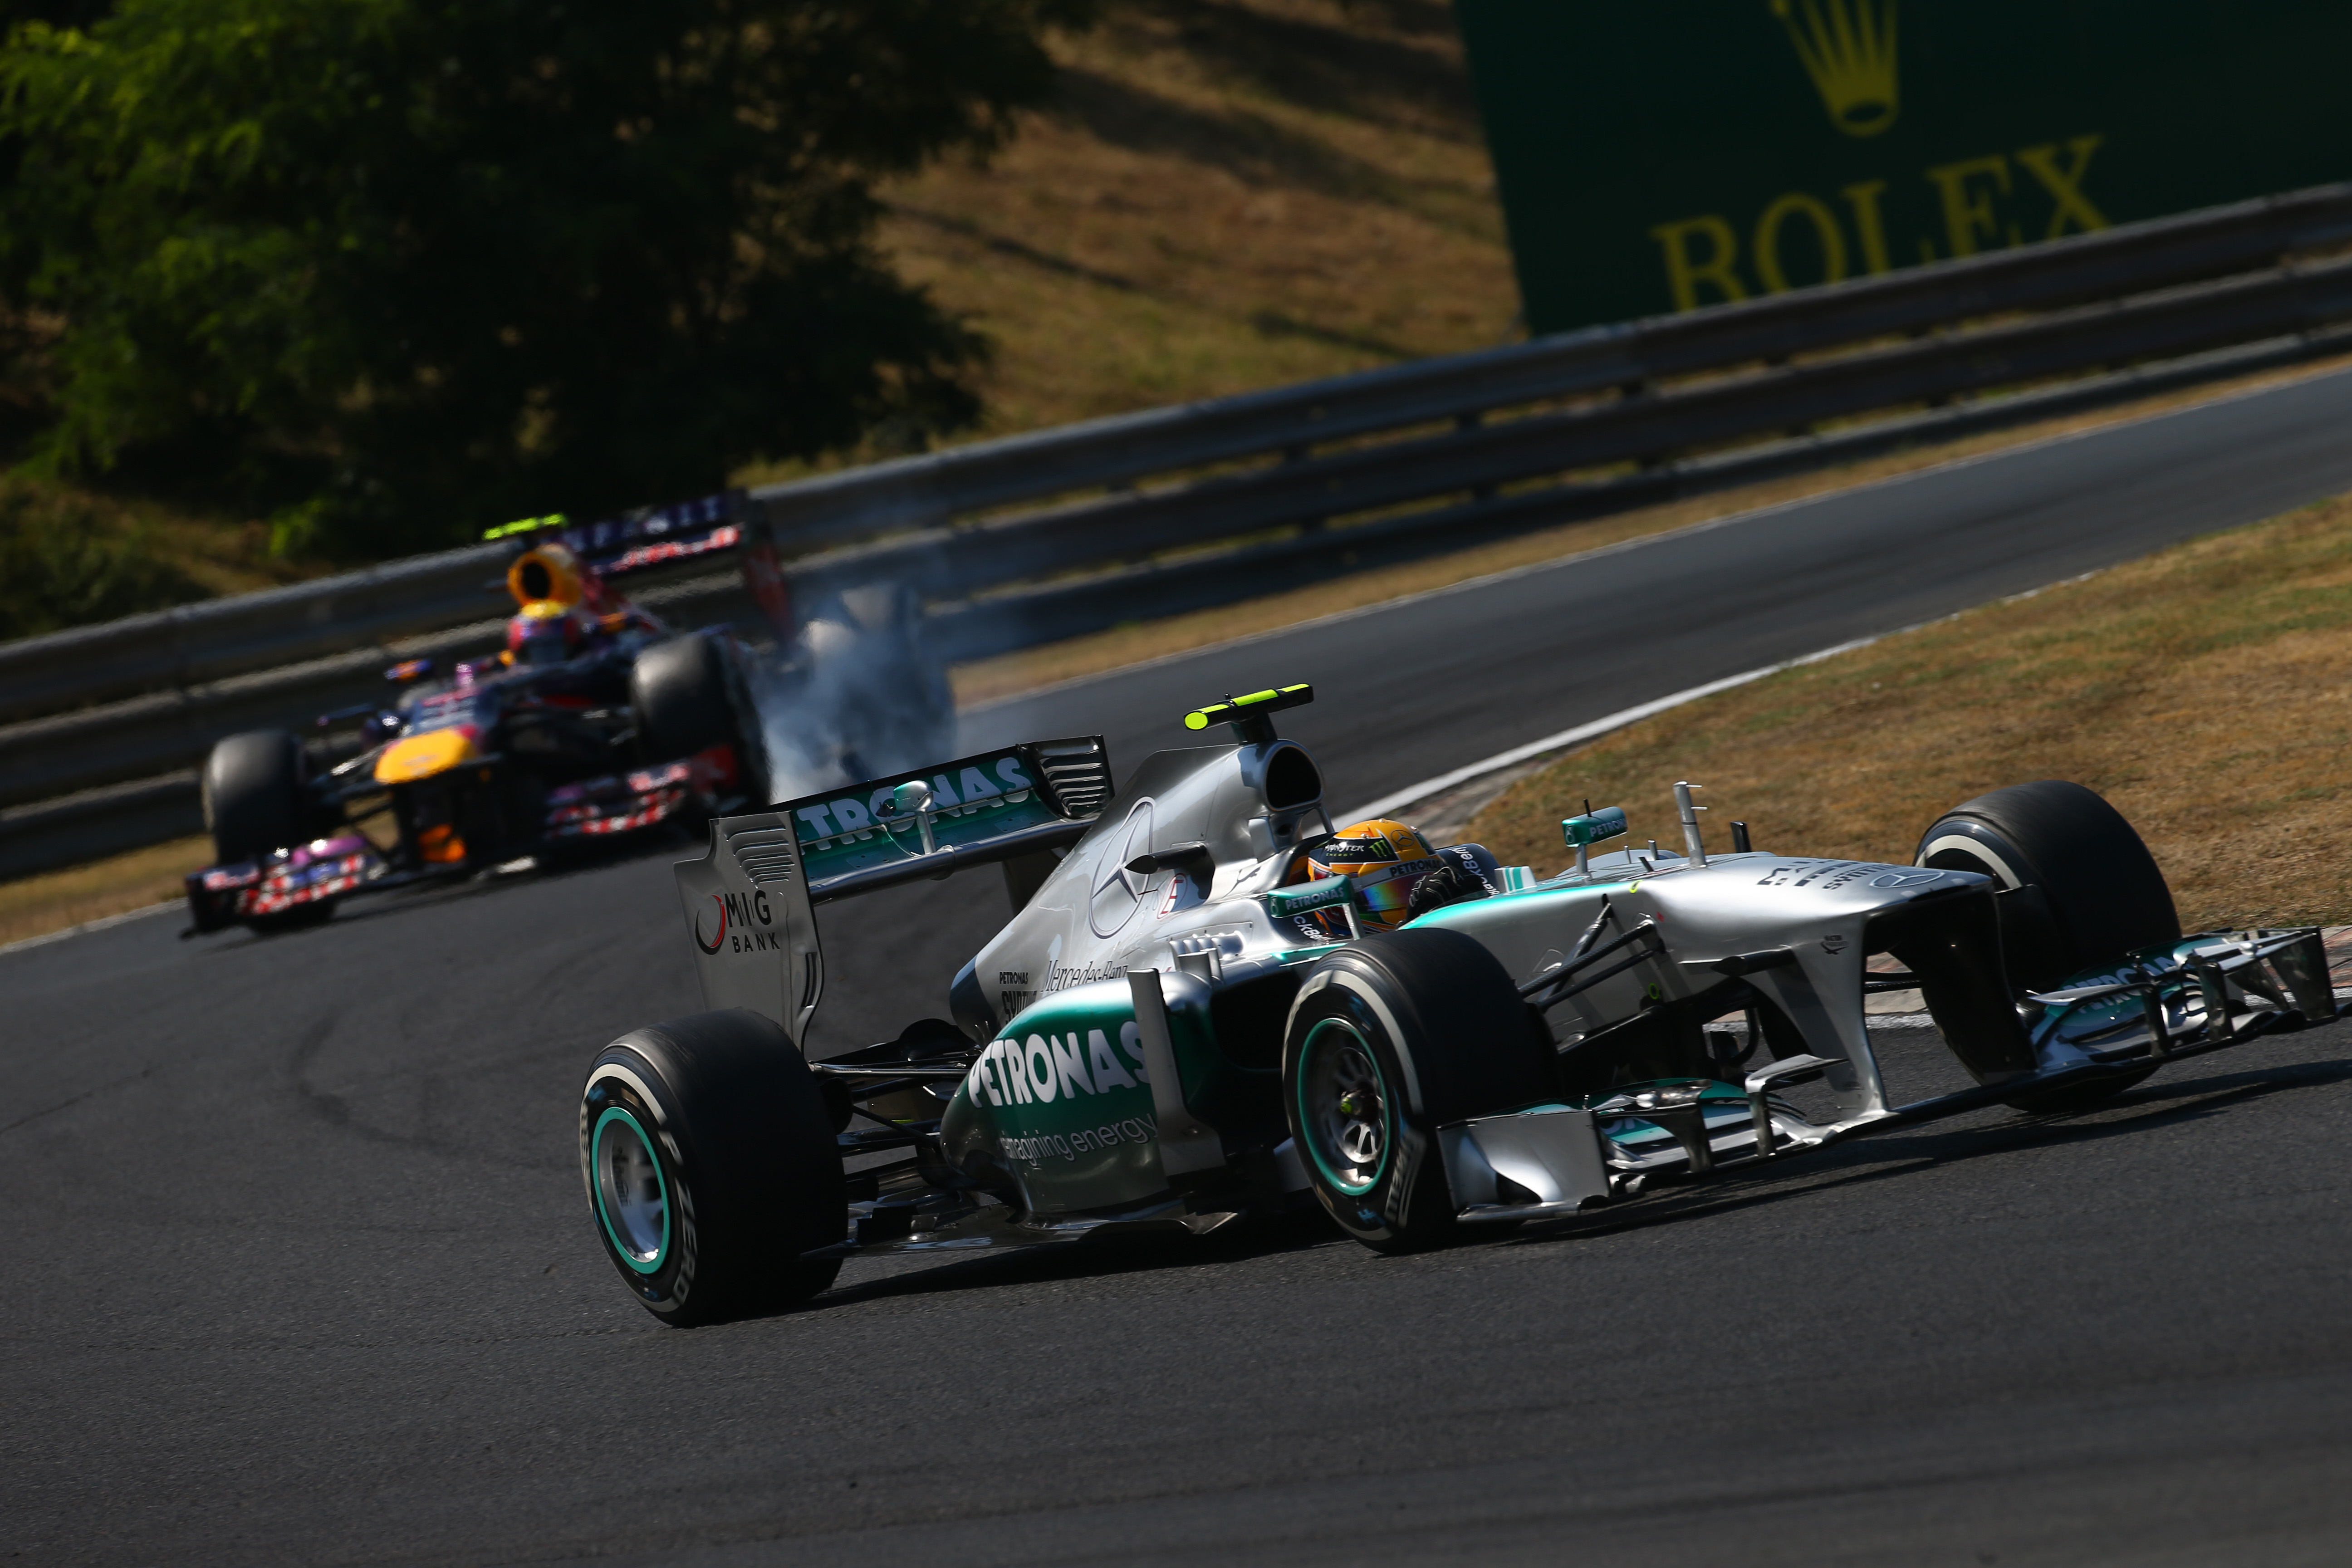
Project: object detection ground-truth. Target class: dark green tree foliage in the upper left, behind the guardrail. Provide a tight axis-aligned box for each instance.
[0,0,1089,553]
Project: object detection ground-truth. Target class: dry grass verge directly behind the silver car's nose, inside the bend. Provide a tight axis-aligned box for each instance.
[1472,498,2352,929]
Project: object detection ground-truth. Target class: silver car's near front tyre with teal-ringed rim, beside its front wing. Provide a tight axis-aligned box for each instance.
[1282,929,1557,1253]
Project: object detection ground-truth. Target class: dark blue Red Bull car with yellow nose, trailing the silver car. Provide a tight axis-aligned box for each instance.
[186,529,769,931]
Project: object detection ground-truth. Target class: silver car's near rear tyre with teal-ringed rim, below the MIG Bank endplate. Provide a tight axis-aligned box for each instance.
[578,1009,849,1328]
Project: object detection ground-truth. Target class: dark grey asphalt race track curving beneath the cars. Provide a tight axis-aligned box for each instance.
[14,376,2352,1568]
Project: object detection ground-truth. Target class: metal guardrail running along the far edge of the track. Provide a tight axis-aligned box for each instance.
[0,186,2352,874]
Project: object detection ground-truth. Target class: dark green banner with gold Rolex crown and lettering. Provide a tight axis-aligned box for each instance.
[1456,0,2352,332]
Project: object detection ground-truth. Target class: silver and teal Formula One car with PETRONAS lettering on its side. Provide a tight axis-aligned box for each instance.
[578,686,2336,1323]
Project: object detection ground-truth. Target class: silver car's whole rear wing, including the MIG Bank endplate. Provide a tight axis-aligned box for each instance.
[677,736,1110,1044]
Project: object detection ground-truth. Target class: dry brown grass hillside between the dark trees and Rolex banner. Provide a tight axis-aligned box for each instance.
[734,0,1519,484]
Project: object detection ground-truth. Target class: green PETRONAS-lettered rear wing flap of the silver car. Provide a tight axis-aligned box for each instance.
[776,736,1110,903]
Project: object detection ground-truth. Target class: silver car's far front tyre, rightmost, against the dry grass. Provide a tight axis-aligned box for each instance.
[1915,778,2180,1114]
